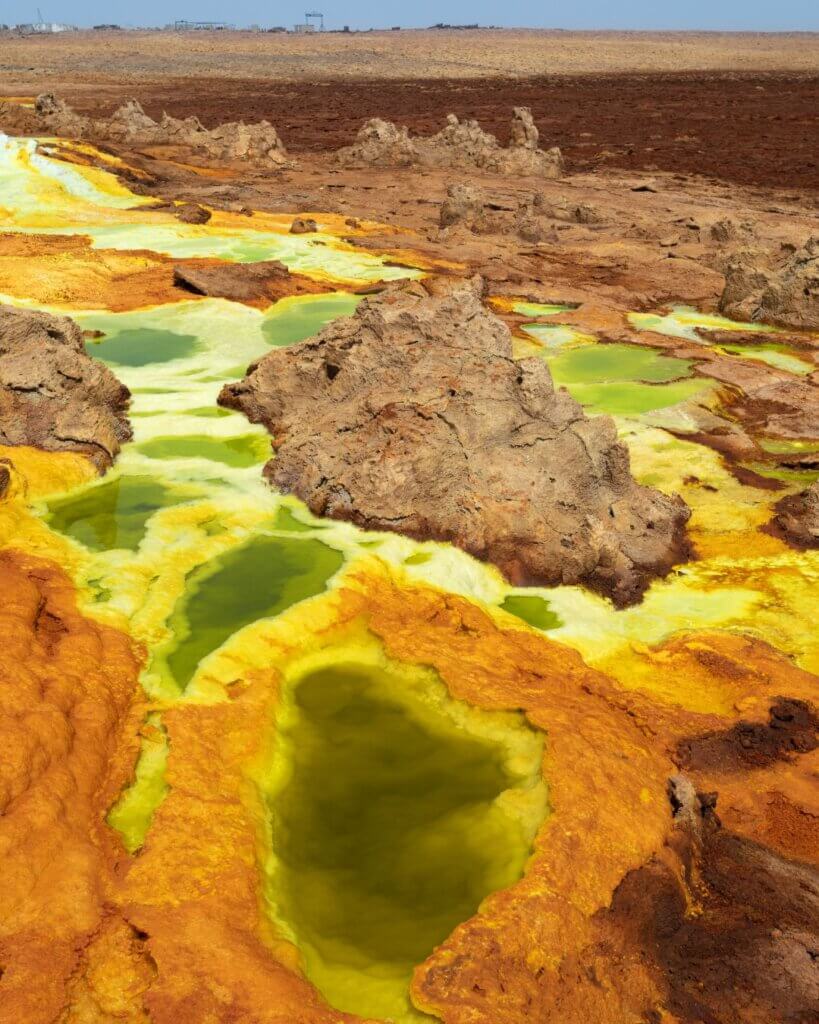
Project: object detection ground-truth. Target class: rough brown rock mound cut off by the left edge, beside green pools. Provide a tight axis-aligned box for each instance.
[0,305,131,469]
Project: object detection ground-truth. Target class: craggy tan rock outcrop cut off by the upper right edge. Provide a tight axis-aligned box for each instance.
[720,236,819,331]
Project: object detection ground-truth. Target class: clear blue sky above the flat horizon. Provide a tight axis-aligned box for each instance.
[0,0,819,31]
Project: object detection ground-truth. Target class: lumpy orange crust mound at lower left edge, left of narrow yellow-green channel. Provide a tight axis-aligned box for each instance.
[0,550,141,1024]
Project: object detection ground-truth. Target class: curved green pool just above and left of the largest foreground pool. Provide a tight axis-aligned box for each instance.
[167,536,344,689]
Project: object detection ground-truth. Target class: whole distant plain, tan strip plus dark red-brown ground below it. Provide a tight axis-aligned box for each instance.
[0,30,819,191]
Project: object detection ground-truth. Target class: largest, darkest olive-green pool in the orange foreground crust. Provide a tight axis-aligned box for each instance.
[270,664,545,1021]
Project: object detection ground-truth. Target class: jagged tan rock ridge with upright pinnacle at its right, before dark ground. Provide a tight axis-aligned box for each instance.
[336,106,563,178]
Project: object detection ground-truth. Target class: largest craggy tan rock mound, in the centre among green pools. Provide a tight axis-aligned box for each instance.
[219,282,689,605]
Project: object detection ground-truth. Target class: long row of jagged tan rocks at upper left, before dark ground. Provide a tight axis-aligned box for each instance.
[35,92,290,167]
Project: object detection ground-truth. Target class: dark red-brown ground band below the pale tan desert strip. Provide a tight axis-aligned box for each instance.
[66,73,819,191]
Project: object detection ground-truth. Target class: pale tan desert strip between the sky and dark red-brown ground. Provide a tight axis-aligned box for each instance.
[0,29,819,79]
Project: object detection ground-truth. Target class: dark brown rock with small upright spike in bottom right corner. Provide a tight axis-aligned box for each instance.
[587,776,819,1024]
